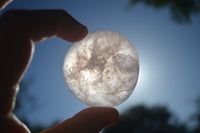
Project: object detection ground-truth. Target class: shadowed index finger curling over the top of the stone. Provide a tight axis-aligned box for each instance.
[0,10,88,114]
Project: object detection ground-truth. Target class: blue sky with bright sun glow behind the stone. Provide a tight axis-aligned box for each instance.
[1,0,200,127]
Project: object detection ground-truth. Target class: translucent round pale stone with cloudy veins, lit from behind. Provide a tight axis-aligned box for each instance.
[63,31,139,107]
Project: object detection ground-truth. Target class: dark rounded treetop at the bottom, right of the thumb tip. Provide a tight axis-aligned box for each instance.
[104,105,189,133]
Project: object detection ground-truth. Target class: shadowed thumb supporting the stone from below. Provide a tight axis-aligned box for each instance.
[42,107,119,133]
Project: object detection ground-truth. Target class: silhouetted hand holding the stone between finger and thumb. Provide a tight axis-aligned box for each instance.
[0,0,119,133]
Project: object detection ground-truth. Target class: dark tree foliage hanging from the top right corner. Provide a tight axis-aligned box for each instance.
[129,0,200,24]
